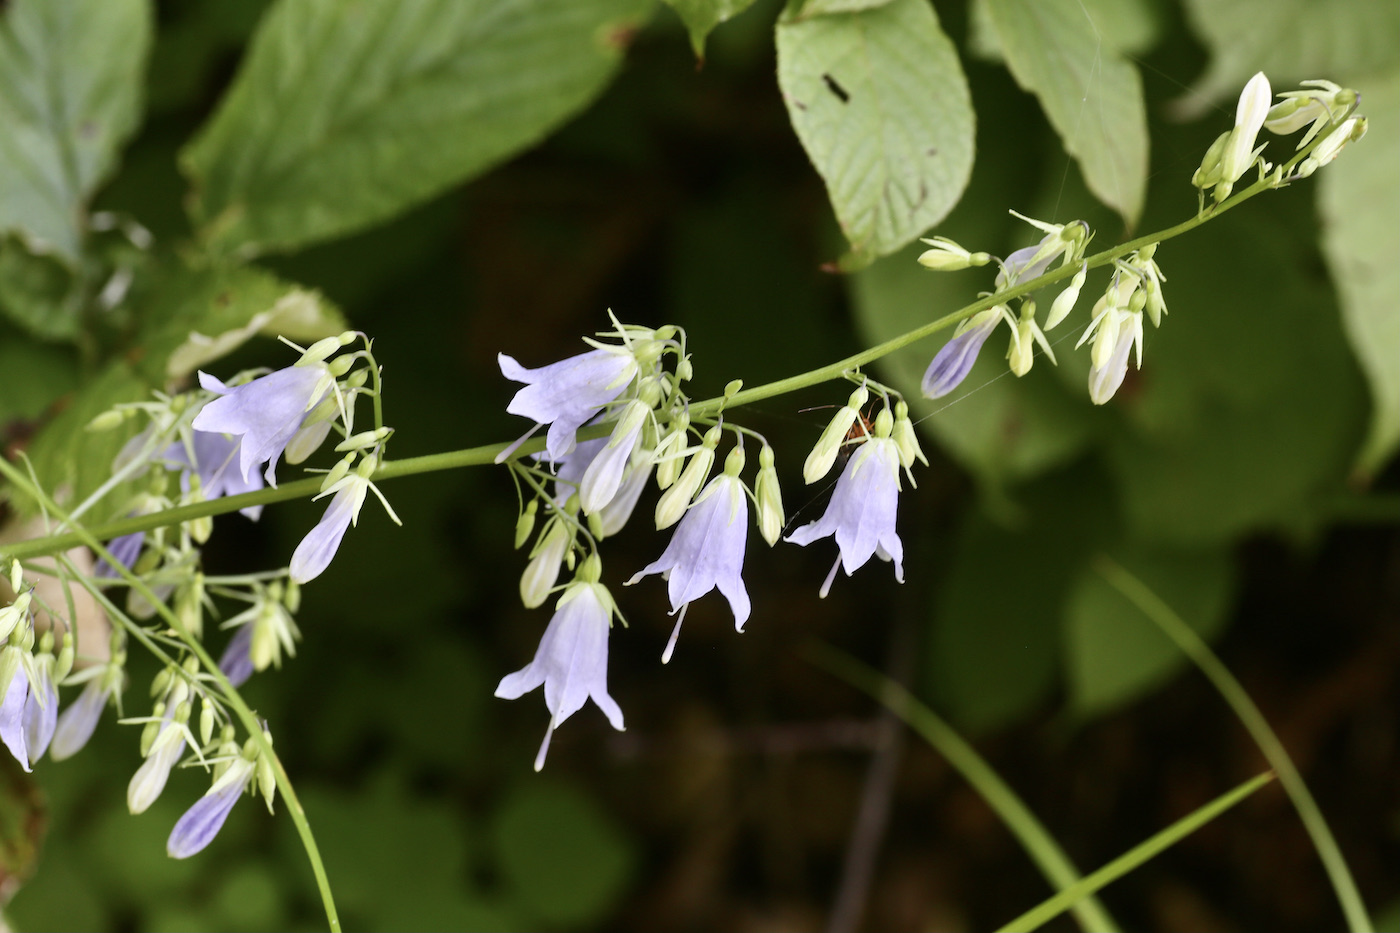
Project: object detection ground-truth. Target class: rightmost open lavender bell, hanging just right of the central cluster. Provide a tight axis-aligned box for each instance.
[787,437,904,597]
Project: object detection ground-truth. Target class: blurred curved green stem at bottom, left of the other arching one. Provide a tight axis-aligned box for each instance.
[806,643,1119,933]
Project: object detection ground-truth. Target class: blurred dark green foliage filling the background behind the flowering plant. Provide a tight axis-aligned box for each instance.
[0,0,1400,930]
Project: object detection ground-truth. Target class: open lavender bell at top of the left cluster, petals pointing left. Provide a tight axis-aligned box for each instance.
[192,363,333,486]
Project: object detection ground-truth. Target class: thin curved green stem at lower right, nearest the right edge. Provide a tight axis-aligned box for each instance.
[1095,555,1375,933]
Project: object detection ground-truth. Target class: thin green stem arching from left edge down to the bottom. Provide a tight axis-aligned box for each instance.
[0,458,340,933]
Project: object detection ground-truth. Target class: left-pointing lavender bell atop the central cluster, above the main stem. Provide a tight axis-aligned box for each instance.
[497,347,637,459]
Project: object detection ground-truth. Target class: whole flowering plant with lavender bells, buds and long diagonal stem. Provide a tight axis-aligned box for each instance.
[0,68,1366,918]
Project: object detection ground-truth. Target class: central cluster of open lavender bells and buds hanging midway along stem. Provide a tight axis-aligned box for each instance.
[496,319,923,769]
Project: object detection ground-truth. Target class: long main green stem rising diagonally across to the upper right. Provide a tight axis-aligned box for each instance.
[6,168,1288,560]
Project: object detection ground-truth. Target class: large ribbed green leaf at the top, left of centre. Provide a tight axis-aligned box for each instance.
[182,0,644,256]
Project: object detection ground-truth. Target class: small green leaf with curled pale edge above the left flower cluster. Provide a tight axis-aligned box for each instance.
[141,259,346,385]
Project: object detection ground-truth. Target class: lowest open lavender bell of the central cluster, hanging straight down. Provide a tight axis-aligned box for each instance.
[496,574,623,770]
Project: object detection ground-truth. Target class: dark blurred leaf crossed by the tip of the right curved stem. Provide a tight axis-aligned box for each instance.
[1064,546,1232,716]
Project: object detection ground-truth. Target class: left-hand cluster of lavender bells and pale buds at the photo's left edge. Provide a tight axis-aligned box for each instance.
[0,332,398,857]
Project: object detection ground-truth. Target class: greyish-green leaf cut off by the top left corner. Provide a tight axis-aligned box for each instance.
[0,0,151,265]
